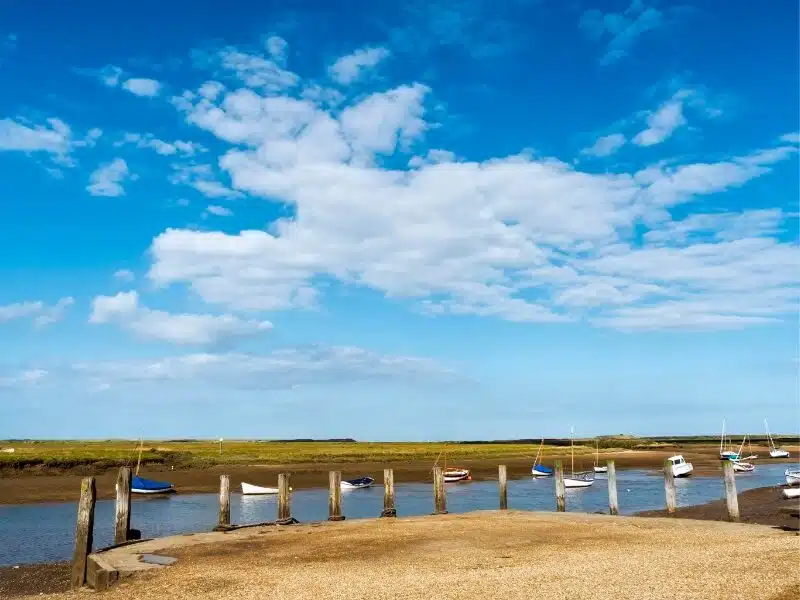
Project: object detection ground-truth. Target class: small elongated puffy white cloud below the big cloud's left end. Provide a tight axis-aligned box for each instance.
[89,291,272,345]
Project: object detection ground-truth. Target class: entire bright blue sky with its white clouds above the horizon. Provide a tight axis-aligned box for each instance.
[0,0,800,440]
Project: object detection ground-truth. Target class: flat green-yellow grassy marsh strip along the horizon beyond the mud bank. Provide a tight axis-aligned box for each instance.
[0,436,798,469]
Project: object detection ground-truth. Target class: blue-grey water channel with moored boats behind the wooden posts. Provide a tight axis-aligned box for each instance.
[0,461,786,566]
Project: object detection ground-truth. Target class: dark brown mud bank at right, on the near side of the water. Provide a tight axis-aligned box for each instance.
[636,486,800,531]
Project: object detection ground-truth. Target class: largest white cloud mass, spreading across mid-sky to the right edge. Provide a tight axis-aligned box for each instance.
[148,43,797,328]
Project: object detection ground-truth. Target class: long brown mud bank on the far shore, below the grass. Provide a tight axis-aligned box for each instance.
[0,445,744,504]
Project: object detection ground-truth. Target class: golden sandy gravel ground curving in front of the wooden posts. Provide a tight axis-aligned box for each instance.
[17,511,800,600]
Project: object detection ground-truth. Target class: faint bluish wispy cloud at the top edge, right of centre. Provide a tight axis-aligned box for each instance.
[579,0,664,65]
